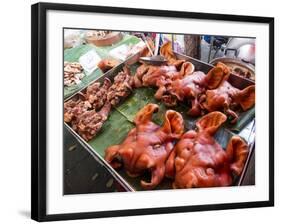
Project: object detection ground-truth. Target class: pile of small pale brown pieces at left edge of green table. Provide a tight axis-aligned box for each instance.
[63,61,85,86]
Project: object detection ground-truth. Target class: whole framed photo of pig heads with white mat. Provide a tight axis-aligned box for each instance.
[31,3,274,221]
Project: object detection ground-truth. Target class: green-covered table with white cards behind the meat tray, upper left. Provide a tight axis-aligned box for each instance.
[64,34,147,99]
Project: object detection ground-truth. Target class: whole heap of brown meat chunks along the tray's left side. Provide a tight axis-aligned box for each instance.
[64,67,132,141]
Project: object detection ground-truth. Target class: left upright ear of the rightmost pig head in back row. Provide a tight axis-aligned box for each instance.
[205,62,230,89]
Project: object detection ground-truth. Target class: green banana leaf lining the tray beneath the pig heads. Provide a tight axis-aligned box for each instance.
[66,57,255,191]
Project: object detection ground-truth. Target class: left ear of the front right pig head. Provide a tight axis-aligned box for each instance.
[196,111,227,135]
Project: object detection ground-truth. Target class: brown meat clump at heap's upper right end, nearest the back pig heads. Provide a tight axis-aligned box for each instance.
[107,67,133,106]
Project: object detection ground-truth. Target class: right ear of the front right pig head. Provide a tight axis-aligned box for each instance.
[226,136,249,176]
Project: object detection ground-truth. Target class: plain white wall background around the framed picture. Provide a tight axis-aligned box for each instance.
[0,0,281,224]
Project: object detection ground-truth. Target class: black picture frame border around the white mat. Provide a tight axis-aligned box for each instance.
[31,3,274,221]
